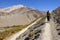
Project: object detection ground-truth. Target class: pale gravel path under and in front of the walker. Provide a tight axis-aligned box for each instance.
[42,19,52,40]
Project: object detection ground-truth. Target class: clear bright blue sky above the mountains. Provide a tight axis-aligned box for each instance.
[0,0,60,11]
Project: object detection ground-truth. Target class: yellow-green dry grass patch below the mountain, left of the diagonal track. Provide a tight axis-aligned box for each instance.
[0,25,26,40]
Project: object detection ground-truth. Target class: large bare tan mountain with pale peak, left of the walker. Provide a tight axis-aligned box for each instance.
[0,5,45,27]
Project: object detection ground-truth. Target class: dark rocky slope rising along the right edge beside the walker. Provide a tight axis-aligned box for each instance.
[52,7,60,40]
